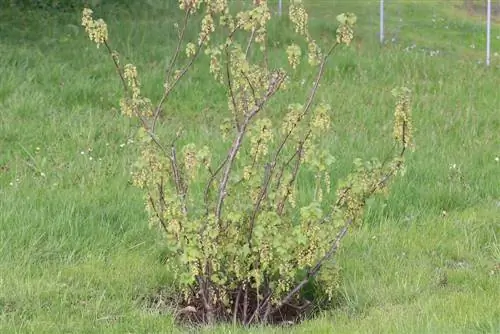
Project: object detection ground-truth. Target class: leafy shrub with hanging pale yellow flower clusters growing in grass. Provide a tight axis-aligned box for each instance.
[82,0,411,325]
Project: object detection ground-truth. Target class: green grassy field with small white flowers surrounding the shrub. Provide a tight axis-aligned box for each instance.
[0,0,500,333]
